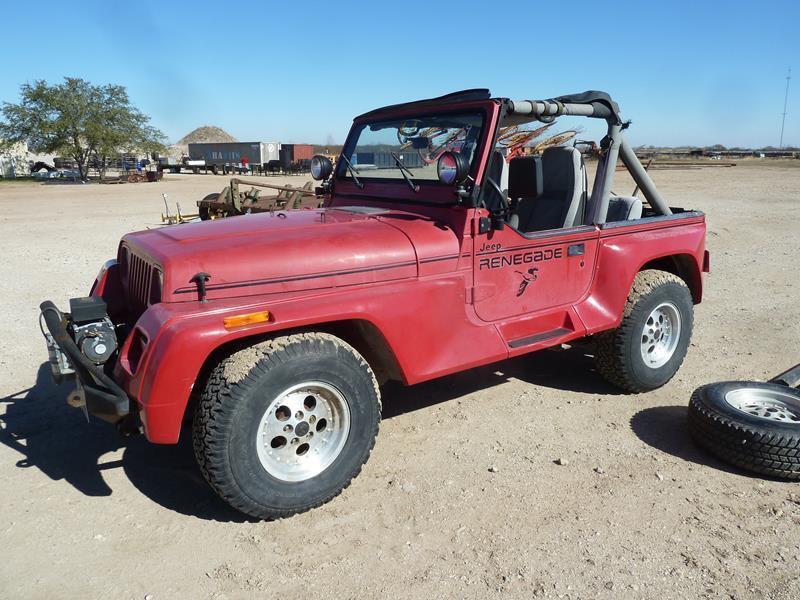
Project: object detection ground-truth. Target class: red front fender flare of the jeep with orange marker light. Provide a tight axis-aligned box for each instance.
[115,273,508,443]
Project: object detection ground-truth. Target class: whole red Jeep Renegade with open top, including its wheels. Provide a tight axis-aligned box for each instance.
[41,90,708,518]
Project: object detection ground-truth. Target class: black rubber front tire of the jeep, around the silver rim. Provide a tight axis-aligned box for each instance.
[193,333,381,519]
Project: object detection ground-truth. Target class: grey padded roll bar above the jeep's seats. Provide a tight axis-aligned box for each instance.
[506,92,672,225]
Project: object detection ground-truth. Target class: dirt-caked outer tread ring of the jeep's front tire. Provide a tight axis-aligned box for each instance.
[192,332,381,519]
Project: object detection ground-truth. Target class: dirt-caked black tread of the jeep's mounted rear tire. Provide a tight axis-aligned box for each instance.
[594,269,688,392]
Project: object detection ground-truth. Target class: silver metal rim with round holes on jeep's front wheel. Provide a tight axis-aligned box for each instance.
[256,381,350,481]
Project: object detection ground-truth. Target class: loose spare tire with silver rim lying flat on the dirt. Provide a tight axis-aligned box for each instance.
[689,381,800,480]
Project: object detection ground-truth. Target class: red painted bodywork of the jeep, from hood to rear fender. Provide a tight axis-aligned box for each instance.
[94,100,708,443]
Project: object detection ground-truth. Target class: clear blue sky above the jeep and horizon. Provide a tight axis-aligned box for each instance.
[0,0,800,146]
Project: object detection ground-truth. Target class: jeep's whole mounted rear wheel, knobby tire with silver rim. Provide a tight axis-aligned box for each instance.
[595,270,694,392]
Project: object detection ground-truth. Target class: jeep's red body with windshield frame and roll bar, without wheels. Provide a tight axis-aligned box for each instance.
[43,91,708,443]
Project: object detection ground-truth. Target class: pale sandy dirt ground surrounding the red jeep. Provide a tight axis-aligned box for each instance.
[0,166,800,600]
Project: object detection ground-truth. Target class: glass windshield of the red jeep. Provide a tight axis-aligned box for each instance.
[337,112,484,185]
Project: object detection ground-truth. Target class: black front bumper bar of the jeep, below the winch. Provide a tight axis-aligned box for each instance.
[39,300,131,423]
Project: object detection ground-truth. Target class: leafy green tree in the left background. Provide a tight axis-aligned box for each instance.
[0,77,165,180]
